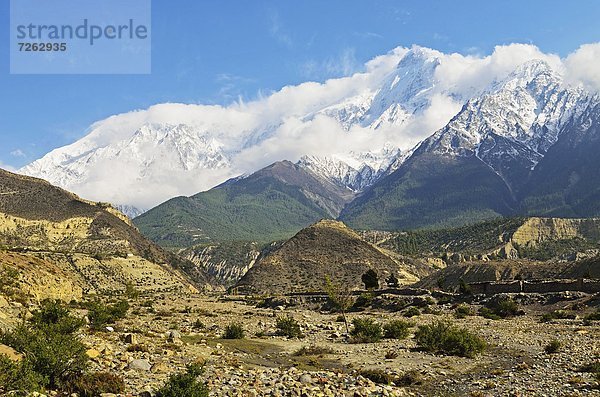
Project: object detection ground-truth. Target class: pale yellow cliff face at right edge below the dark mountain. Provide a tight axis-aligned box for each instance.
[511,217,600,247]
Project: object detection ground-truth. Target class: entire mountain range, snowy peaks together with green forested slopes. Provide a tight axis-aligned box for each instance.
[21,47,600,241]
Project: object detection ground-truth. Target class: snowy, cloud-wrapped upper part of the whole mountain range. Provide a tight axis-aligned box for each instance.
[21,46,585,215]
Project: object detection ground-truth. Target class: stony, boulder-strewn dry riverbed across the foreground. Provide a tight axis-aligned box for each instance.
[62,294,600,397]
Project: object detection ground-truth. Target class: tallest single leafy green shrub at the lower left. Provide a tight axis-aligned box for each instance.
[0,300,88,388]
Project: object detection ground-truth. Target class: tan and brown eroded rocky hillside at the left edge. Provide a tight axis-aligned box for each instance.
[0,170,210,299]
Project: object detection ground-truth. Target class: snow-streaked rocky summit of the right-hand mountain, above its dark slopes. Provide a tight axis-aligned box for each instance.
[419,60,589,193]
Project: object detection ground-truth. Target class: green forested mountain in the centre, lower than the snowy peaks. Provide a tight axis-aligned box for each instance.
[135,161,352,247]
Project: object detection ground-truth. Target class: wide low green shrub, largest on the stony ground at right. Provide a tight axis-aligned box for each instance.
[415,321,486,357]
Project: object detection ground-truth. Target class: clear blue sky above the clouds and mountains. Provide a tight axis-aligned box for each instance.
[0,0,600,167]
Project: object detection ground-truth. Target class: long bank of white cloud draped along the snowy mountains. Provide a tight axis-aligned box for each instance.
[21,43,600,208]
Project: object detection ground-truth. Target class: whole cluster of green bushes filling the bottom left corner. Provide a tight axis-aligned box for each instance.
[0,300,124,397]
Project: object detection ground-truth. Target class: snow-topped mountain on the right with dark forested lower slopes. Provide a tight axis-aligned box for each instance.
[340,60,600,230]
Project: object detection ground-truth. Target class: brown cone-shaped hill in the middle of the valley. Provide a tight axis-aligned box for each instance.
[234,220,432,294]
